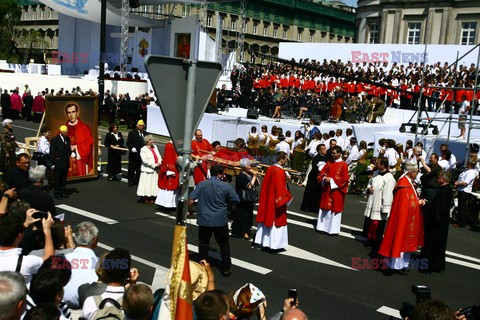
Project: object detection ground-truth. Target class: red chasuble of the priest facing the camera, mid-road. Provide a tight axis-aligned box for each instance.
[317,161,349,213]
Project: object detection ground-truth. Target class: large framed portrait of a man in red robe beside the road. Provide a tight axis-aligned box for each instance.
[44,95,98,180]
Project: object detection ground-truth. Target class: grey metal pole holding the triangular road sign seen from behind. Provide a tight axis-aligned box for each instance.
[177,60,197,225]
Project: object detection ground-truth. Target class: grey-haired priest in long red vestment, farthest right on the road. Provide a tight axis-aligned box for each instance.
[378,161,425,272]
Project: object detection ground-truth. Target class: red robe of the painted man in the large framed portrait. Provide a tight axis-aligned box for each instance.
[66,119,94,177]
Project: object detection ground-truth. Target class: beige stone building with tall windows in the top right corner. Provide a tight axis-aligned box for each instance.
[356,0,480,45]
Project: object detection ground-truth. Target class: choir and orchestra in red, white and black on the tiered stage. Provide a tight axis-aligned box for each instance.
[217,59,480,122]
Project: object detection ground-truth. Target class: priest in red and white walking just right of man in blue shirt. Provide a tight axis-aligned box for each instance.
[254,151,293,250]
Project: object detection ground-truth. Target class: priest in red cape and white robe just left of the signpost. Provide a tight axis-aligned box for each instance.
[155,141,180,208]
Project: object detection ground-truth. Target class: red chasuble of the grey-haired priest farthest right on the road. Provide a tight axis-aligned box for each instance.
[378,176,423,258]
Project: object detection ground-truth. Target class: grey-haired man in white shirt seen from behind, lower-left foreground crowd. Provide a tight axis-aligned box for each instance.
[63,221,98,309]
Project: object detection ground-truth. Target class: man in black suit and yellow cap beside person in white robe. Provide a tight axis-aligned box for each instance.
[127,120,147,187]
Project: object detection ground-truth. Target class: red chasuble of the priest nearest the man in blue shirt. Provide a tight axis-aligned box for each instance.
[257,166,292,228]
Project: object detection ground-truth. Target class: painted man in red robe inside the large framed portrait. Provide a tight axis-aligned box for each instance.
[65,103,95,177]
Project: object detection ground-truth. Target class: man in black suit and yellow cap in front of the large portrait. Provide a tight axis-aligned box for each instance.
[50,125,72,200]
